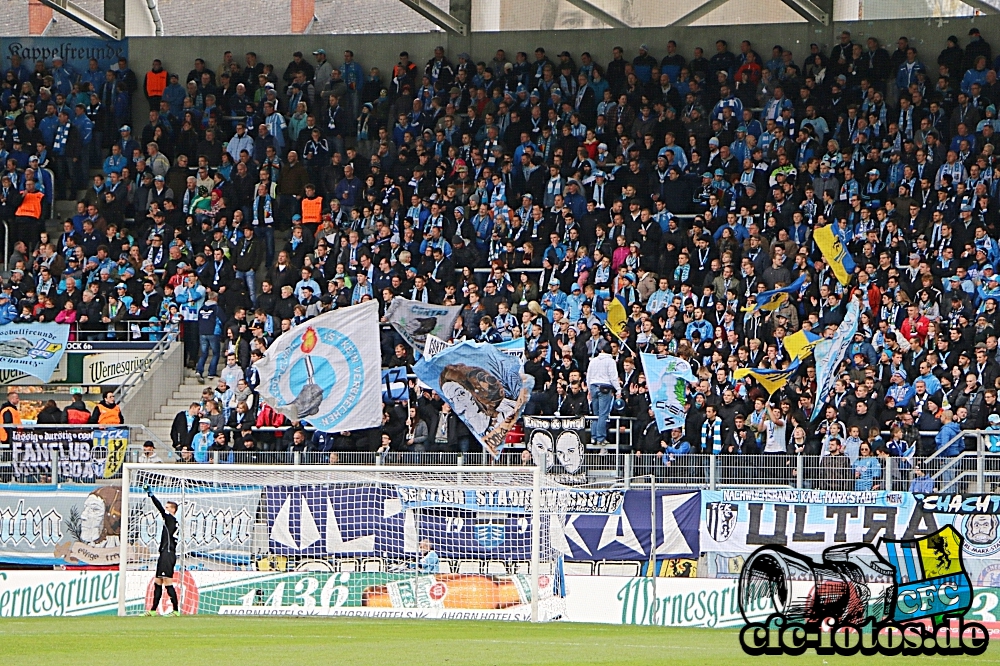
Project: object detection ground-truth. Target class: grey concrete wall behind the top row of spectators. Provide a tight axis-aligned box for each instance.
[129,16,1000,127]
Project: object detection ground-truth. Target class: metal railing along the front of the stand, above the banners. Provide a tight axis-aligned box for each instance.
[0,417,1000,493]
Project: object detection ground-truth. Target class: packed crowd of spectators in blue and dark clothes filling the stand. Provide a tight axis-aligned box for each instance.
[0,28,1000,482]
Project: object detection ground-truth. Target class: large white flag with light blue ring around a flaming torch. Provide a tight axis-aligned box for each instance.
[254,300,382,432]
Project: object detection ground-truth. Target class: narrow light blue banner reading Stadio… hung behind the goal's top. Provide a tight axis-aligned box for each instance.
[397,486,625,515]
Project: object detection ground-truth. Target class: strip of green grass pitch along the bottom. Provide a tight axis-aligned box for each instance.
[0,616,1000,666]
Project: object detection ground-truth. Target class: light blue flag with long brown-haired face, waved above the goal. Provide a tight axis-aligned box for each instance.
[413,341,535,457]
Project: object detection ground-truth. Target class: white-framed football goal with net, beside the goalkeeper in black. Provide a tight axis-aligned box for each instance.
[119,464,580,621]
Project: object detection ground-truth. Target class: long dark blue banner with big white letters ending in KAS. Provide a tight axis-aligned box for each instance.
[264,486,699,561]
